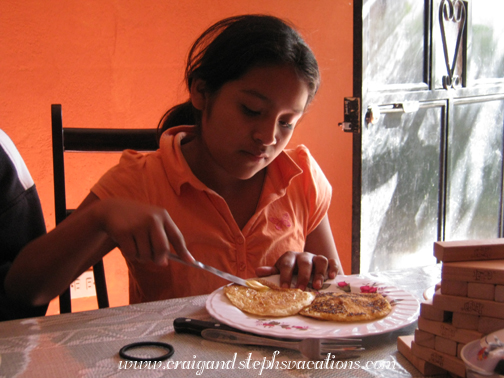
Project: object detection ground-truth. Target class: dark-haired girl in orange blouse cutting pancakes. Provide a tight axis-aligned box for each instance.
[6,15,341,305]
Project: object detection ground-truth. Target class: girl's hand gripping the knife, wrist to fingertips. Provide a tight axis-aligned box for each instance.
[97,198,194,266]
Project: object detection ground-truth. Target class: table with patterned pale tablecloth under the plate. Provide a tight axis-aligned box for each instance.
[0,265,441,378]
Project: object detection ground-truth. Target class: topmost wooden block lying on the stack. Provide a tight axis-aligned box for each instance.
[434,238,504,262]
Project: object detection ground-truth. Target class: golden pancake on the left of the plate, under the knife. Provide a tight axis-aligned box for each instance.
[224,280,315,317]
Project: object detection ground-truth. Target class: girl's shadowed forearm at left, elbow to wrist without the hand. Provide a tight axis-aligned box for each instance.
[5,193,115,306]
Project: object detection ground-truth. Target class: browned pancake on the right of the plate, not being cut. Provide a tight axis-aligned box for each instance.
[299,292,392,322]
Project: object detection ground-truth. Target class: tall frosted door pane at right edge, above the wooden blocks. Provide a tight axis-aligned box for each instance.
[445,100,504,240]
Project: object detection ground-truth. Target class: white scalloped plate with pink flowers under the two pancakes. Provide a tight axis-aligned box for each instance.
[206,275,420,339]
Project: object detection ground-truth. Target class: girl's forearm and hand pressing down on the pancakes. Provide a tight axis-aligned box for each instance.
[256,215,343,290]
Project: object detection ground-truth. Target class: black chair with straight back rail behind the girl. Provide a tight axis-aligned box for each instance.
[51,104,158,314]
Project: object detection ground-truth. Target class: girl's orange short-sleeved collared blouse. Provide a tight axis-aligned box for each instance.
[91,126,331,303]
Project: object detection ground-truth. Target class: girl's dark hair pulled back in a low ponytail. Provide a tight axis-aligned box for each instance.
[158,15,320,139]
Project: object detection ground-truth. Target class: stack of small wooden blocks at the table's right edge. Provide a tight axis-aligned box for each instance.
[397,239,504,377]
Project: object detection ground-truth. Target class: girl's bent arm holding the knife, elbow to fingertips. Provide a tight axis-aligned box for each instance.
[5,193,193,306]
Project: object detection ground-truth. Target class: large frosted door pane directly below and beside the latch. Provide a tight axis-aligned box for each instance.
[360,108,442,272]
